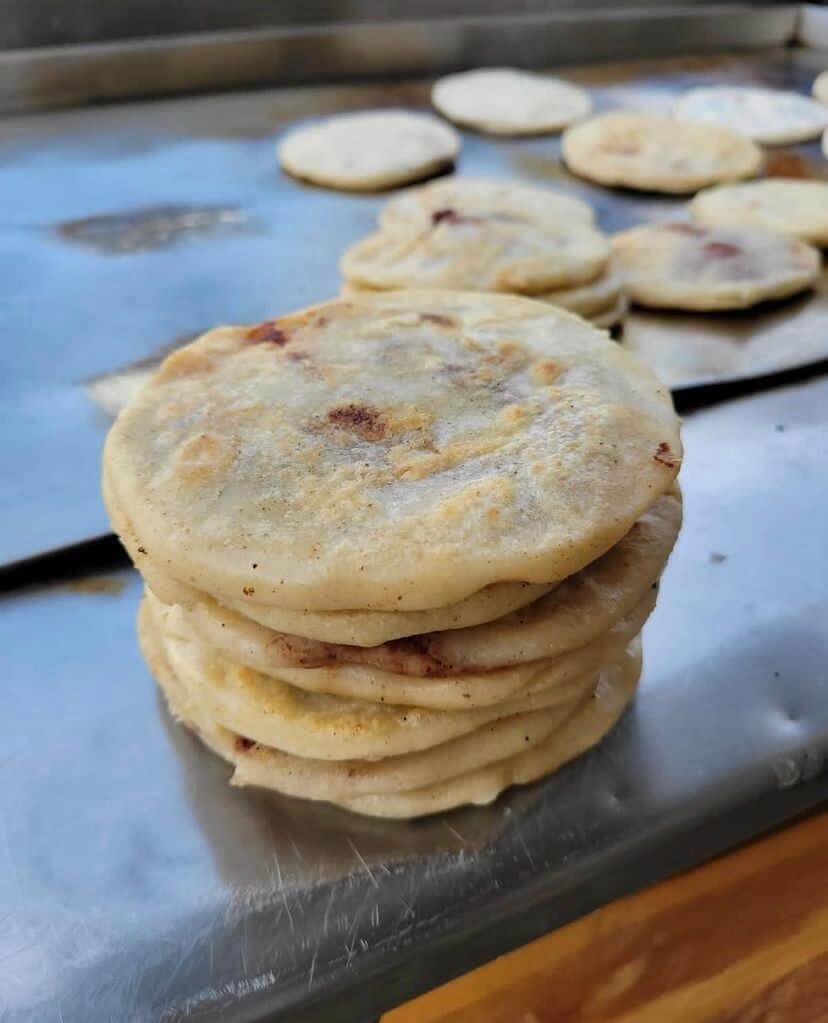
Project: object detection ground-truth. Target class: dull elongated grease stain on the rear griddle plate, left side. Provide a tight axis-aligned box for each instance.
[55,204,251,256]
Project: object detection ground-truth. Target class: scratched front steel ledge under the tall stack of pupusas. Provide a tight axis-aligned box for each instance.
[0,379,828,1023]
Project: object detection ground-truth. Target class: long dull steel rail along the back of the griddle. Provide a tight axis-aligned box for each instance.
[0,2,799,112]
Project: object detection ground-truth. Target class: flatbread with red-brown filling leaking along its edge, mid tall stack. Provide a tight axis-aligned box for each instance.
[172,494,682,683]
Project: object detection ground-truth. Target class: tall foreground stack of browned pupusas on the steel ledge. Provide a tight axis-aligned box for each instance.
[103,292,681,817]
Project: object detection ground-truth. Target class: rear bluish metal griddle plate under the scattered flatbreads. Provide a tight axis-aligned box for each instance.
[0,50,828,566]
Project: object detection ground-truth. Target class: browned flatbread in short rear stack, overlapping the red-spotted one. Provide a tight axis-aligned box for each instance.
[340,203,610,294]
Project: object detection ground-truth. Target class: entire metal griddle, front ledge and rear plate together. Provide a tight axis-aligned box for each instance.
[0,31,828,1023]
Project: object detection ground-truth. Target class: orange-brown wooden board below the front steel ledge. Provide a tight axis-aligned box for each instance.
[383,814,828,1023]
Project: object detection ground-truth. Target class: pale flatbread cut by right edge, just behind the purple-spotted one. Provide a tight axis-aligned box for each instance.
[690,178,828,246]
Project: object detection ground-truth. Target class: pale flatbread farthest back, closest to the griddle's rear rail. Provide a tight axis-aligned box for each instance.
[431,68,593,135]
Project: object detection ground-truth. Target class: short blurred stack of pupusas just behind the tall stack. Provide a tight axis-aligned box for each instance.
[341,177,626,329]
